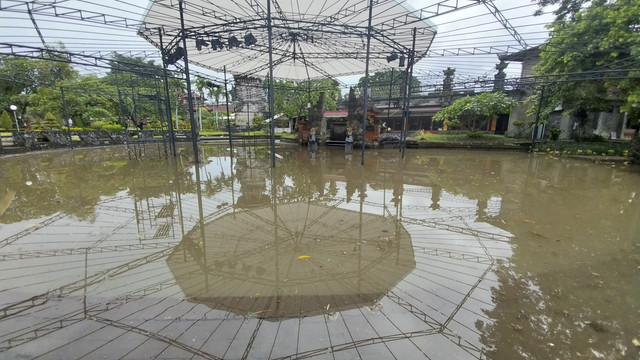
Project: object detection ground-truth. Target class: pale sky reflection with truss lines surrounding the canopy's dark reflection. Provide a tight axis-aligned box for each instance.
[0,183,510,359]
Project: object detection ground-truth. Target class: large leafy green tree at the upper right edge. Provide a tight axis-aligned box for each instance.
[529,0,640,126]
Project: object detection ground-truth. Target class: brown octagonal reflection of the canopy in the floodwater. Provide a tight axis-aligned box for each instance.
[167,203,415,318]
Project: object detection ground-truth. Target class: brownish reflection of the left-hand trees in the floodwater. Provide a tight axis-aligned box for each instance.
[0,148,195,223]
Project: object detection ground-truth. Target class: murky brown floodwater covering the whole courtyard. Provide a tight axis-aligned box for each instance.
[0,145,640,360]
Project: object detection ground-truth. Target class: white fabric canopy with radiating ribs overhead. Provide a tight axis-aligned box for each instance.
[138,0,436,81]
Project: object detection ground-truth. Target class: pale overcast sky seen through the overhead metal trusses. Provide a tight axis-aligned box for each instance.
[0,0,552,90]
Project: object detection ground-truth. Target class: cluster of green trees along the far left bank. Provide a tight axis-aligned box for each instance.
[0,54,186,132]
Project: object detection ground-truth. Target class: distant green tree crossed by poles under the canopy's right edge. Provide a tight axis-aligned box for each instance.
[357,71,421,104]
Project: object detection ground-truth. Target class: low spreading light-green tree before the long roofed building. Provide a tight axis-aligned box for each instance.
[433,92,517,131]
